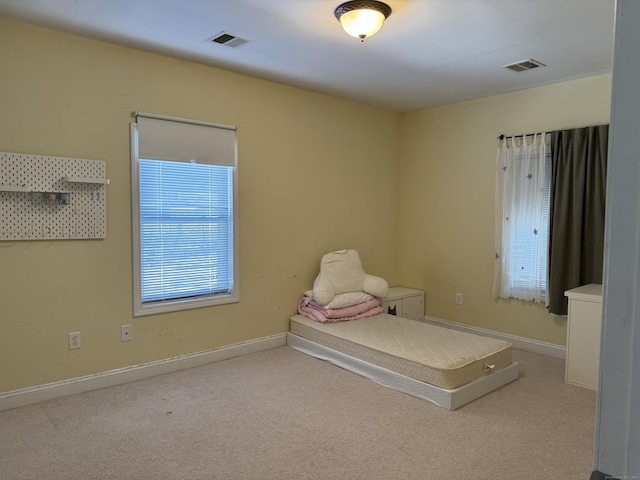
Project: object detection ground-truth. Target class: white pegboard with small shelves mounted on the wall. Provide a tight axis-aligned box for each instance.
[0,152,109,240]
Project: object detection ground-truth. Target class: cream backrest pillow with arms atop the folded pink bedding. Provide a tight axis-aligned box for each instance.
[313,250,389,305]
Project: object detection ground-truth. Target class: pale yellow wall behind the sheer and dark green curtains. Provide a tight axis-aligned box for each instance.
[398,73,611,345]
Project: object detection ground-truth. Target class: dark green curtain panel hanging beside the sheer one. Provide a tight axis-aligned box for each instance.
[547,125,609,315]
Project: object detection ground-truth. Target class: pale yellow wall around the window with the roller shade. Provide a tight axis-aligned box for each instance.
[0,19,400,392]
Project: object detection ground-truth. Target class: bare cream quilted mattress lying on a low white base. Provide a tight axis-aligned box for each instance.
[290,313,512,389]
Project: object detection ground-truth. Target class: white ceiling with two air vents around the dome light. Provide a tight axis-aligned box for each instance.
[0,0,615,111]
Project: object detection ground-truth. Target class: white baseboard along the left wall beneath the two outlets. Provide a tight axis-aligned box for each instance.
[0,333,287,411]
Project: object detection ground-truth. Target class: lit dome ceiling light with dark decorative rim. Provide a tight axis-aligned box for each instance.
[334,0,391,42]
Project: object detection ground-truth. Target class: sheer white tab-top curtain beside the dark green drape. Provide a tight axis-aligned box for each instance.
[493,133,551,302]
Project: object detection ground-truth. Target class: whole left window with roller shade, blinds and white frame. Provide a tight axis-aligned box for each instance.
[131,113,238,315]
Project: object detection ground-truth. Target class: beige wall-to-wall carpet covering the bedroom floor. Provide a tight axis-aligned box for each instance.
[0,347,595,480]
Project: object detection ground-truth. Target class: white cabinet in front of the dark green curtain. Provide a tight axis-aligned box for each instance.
[564,283,602,390]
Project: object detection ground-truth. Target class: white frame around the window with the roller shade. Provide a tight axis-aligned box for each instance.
[130,112,240,317]
